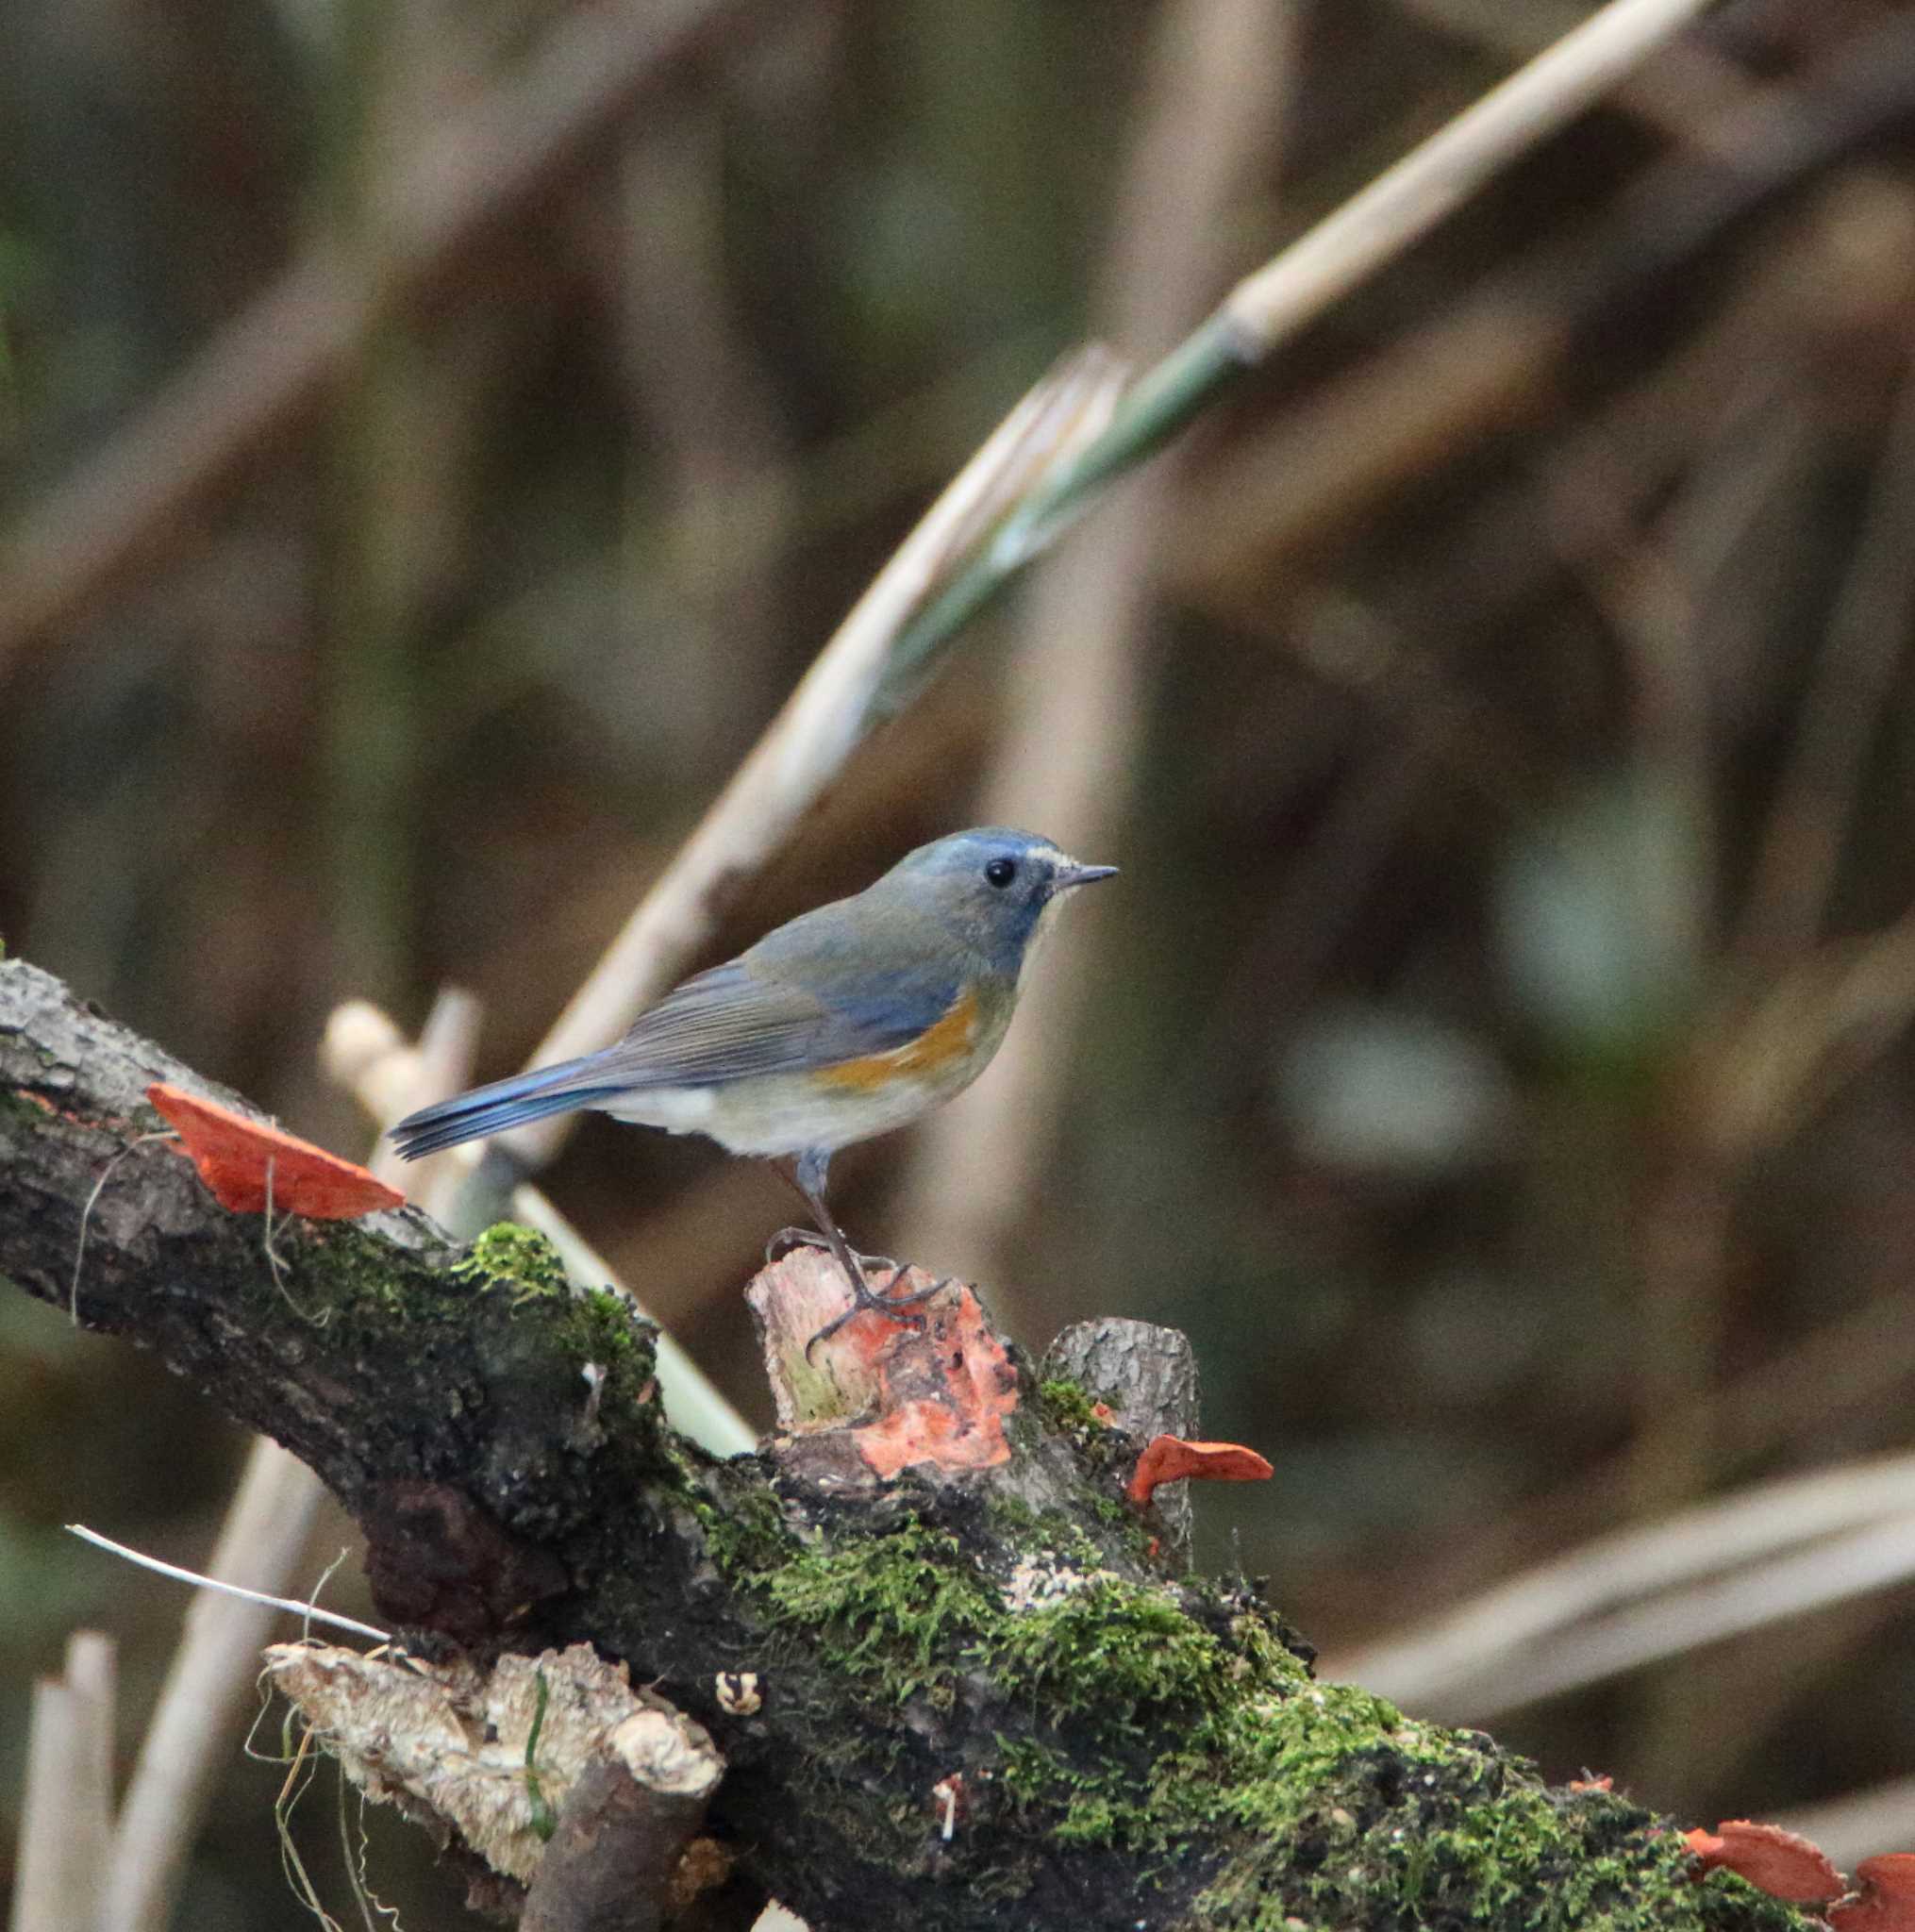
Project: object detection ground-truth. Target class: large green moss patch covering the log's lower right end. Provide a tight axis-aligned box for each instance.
[993,1582,1807,1932]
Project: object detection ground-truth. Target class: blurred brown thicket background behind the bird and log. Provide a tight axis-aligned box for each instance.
[0,0,1915,1928]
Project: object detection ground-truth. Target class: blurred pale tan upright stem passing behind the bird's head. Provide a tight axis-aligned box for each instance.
[901,0,1299,1327]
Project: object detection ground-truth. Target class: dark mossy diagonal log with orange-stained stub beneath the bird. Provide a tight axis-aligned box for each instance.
[0,962,1808,1932]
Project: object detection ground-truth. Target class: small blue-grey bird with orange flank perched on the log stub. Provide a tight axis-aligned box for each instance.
[392,827,1117,1349]
